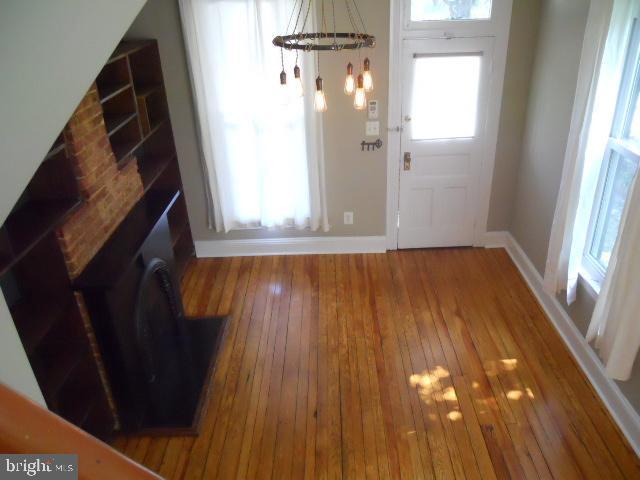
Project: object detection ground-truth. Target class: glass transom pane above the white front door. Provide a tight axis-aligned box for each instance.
[411,0,491,22]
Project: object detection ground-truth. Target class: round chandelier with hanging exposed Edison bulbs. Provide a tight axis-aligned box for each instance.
[273,0,376,112]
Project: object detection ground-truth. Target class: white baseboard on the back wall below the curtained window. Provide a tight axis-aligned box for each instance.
[195,236,387,258]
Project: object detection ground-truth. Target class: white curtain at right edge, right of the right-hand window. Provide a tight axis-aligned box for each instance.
[587,174,640,380]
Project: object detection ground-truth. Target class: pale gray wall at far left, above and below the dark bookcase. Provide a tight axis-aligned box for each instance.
[0,0,144,403]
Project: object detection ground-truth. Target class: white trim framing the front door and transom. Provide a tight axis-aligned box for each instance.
[386,0,513,250]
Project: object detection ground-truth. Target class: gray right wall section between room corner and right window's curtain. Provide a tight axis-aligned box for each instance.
[510,0,589,274]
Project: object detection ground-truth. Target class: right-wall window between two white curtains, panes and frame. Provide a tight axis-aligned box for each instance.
[583,22,640,283]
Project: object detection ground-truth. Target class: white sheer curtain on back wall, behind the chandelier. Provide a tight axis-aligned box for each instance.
[180,0,329,232]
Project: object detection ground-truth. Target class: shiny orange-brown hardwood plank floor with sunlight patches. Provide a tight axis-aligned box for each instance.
[115,249,640,480]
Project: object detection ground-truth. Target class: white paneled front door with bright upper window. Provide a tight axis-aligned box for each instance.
[398,37,493,248]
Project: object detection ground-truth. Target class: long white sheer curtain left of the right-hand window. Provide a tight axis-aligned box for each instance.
[544,0,634,303]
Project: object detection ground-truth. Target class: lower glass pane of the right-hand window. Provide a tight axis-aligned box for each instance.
[590,152,637,270]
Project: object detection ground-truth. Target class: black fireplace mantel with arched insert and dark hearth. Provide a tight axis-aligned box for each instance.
[73,190,226,435]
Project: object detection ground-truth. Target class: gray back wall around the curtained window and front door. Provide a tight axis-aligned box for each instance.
[127,0,540,240]
